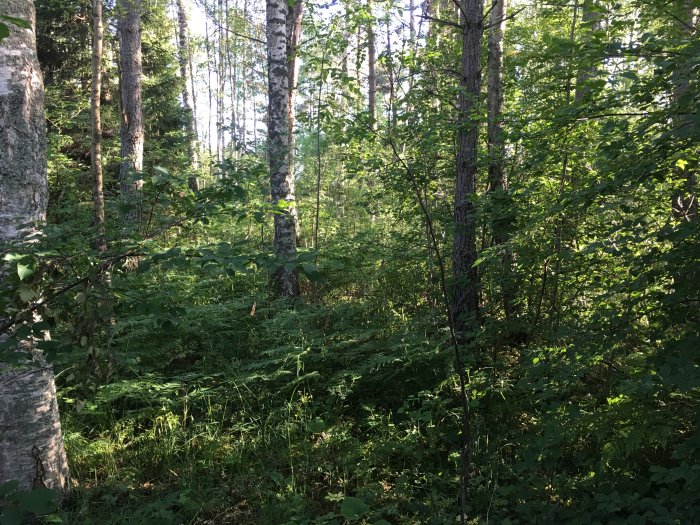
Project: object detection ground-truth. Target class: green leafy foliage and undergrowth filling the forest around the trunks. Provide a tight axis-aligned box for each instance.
[0,1,700,524]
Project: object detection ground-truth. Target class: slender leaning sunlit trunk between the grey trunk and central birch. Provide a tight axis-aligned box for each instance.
[176,0,199,172]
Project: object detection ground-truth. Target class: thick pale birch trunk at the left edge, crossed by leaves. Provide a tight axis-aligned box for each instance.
[0,0,69,492]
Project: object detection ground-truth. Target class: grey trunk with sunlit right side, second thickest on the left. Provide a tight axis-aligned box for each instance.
[118,0,145,220]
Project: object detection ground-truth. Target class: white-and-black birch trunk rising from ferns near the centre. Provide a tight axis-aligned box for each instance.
[267,0,299,297]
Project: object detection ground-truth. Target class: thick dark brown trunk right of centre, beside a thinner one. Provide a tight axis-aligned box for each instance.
[452,0,484,332]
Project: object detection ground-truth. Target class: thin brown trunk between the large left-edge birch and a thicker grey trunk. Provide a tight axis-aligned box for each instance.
[91,0,107,252]
